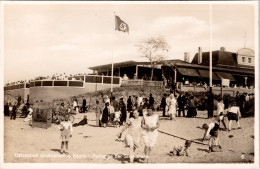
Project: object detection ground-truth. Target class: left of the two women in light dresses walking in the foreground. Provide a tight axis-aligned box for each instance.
[117,110,143,163]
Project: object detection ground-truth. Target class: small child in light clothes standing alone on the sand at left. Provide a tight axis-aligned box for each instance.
[59,114,73,154]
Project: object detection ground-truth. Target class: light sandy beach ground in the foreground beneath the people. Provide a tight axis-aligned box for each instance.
[4,111,254,163]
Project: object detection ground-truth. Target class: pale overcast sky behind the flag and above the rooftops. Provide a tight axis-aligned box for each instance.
[4,2,257,83]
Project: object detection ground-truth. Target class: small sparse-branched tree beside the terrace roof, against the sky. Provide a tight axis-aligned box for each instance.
[136,36,170,80]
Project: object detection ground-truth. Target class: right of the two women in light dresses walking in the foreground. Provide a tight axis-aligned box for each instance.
[142,108,160,163]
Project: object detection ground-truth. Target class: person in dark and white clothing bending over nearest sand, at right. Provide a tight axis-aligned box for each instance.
[202,120,219,152]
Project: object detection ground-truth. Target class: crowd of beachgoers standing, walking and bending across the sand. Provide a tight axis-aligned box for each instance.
[4,91,250,163]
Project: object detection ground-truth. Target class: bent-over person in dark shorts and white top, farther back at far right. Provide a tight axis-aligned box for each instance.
[227,102,241,131]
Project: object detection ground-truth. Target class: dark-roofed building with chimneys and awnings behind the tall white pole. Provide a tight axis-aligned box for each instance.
[162,47,255,88]
